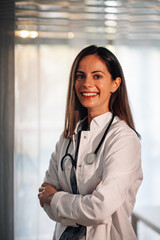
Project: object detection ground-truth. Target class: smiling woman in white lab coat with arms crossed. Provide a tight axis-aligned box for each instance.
[38,46,142,240]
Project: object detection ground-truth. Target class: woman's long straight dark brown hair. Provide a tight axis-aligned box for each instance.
[64,45,135,138]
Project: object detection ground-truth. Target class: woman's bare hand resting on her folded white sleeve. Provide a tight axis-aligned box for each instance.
[38,183,58,207]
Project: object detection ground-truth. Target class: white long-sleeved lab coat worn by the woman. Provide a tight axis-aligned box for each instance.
[44,112,142,240]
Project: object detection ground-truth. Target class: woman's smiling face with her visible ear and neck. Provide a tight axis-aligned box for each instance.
[75,55,120,118]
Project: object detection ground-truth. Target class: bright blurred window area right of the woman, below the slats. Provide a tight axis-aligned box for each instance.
[117,46,160,205]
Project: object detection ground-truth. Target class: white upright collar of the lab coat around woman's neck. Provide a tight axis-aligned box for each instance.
[74,112,112,134]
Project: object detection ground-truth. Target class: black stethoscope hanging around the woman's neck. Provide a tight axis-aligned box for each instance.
[61,114,114,171]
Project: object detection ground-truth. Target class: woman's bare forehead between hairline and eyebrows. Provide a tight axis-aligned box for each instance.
[78,55,108,71]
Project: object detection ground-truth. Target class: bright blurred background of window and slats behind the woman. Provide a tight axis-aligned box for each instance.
[0,0,160,240]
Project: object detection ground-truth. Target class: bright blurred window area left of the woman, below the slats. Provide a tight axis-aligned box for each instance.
[15,44,79,240]
